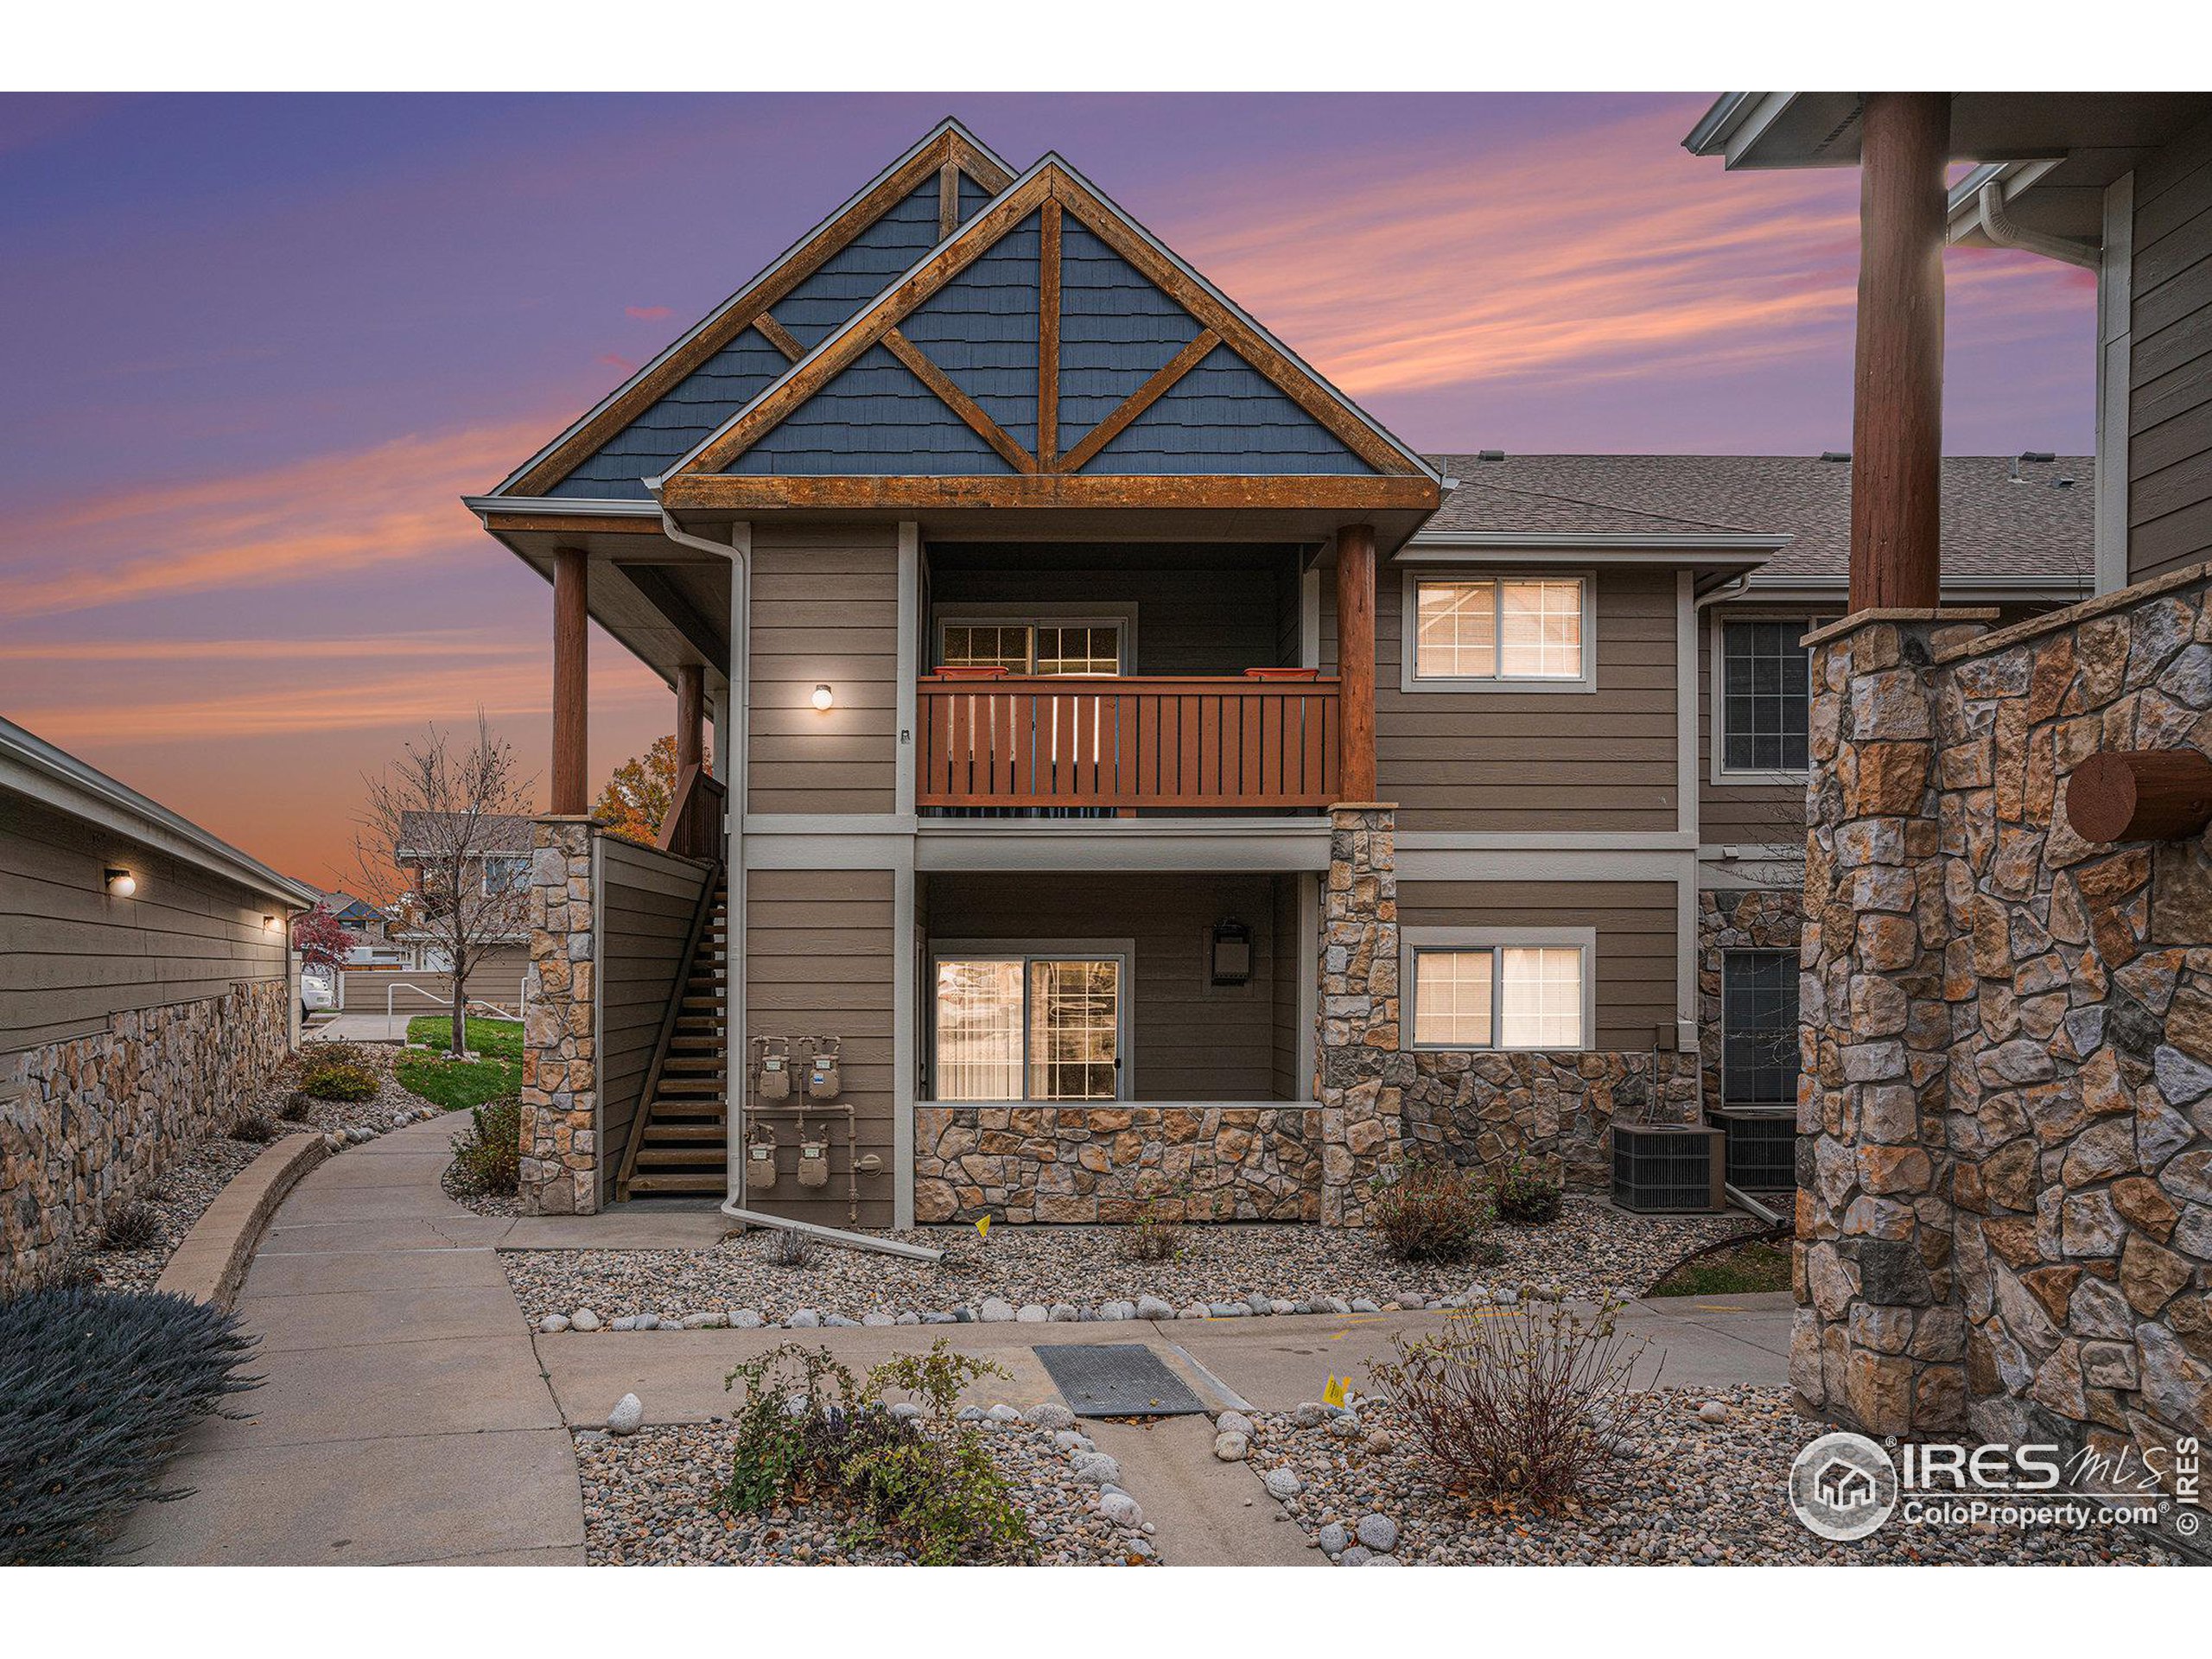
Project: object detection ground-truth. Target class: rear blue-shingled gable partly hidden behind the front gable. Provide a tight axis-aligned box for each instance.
[491,119,1013,502]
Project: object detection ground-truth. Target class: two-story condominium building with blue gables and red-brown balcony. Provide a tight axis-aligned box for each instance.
[469,122,2090,1225]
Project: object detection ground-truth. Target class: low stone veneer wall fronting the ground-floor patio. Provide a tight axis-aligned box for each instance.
[913,1103,1320,1224]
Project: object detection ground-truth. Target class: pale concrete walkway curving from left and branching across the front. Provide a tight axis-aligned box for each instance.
[124,1119,1789,1566]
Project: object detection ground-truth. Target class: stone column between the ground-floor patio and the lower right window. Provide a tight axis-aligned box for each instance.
[1314,801,1411,1228]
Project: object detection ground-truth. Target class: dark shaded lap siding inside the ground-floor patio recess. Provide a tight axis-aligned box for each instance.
[929,874,1303,1102]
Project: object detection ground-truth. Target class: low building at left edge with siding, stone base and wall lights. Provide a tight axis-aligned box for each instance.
[0,719,316,1292]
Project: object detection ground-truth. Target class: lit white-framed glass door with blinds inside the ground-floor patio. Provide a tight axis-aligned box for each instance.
[929,940,1135,1102]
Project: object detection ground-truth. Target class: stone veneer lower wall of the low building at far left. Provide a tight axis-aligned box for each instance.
[0,980,292,1292]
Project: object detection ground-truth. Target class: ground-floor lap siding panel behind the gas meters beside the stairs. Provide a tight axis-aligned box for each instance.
[732,869,902,1228]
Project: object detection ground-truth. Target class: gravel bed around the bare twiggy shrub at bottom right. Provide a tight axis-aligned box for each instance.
[1249,1387,2177,1566]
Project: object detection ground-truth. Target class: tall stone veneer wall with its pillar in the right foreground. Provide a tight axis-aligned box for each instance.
[1792,583,2212,1455]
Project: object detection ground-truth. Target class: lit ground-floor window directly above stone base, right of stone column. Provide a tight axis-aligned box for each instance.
[1400,927,1597,1048]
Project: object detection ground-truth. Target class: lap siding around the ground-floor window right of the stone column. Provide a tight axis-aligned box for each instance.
[1398,880,1675,1051]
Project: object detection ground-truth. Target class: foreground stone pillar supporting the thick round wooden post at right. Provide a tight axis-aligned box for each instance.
[1789,613,1964,1435]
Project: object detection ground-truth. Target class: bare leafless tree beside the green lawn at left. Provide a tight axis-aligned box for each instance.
[354,710,533,1055]
